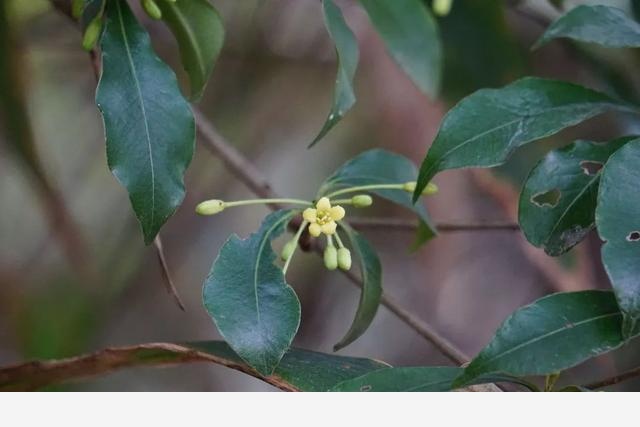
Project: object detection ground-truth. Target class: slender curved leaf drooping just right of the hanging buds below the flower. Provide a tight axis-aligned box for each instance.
[333,223,382,351]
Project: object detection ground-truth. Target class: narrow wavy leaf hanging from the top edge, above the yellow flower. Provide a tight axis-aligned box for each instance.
[309,0,360,147]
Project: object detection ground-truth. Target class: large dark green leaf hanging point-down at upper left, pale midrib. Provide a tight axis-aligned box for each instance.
[96,0,195,244]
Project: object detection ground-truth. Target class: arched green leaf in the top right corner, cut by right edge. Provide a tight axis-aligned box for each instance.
[533,5,640,49]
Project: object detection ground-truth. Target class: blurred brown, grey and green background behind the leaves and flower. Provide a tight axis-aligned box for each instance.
[0,0,640,391]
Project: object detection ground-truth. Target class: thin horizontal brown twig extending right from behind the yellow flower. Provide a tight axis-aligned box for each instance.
[349,218,520,233]
